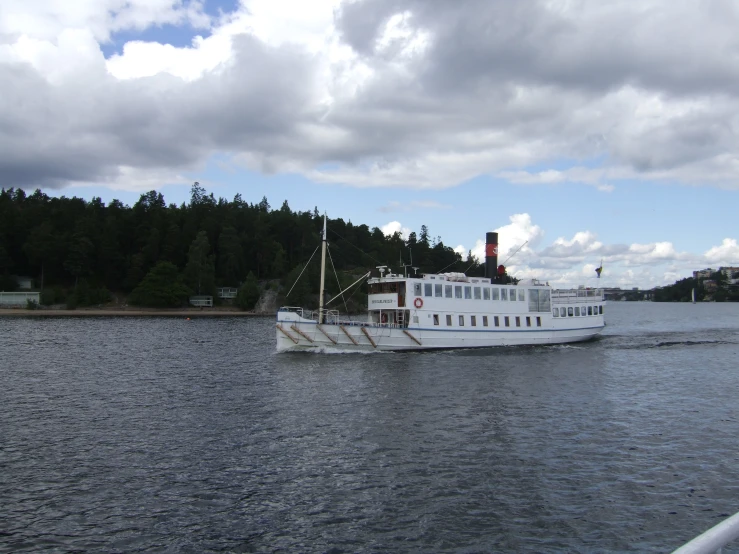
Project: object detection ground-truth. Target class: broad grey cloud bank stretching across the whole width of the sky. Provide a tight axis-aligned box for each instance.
[0,0,739,190]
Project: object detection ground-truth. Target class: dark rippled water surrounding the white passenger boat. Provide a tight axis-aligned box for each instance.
[0,303,739,553]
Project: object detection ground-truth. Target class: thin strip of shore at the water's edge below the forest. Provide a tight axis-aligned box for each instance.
[0,308,266,318]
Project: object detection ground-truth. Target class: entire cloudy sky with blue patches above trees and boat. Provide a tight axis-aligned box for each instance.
[0,0,739,288]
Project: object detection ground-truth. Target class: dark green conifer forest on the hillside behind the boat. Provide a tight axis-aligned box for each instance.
[0,182,474,309]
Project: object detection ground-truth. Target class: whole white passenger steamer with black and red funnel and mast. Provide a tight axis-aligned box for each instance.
[276,217,605,352]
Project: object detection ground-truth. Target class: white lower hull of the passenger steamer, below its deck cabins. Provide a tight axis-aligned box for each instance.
[276,312,604,352]
